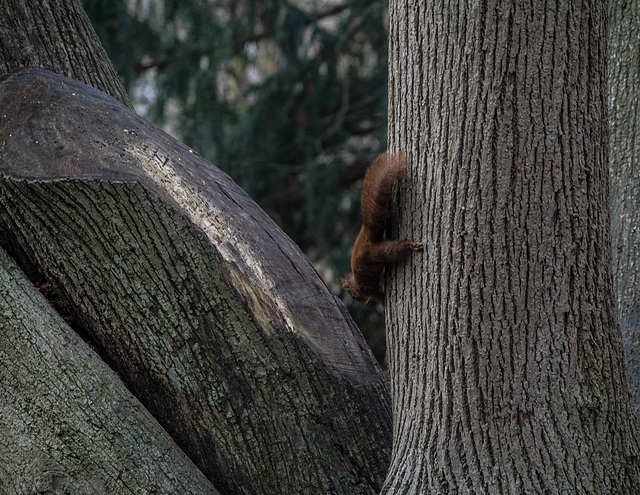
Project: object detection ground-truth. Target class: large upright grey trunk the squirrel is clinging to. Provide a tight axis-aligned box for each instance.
[383,0,640,494]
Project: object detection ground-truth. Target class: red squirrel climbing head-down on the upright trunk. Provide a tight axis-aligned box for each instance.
[339,152,422,306]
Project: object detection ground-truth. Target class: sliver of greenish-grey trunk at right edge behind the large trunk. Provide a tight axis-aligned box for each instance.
[609,0,640,420]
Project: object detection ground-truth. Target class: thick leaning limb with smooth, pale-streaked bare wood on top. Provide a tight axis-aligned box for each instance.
[0,70,391,494]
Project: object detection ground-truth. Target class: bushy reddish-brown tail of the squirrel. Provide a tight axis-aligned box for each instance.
[360,152,407,240]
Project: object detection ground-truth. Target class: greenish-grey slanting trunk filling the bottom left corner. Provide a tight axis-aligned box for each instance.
[0,248,218,495]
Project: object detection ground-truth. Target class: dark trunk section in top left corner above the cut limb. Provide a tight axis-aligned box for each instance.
[0,0,133,108]
